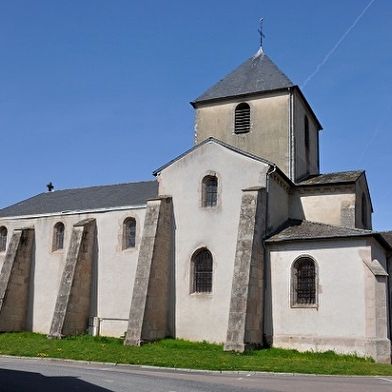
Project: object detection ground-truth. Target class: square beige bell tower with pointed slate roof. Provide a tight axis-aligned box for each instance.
[191,44,322,182]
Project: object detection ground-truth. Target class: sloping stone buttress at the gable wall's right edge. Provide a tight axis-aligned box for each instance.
[224,189,266,352]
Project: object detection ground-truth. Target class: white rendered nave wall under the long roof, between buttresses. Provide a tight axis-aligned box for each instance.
[0,208,145,336]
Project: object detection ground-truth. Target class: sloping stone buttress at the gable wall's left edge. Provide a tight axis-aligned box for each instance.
[125,197,172,346]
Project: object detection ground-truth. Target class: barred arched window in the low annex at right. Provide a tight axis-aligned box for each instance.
[292,257,316,306]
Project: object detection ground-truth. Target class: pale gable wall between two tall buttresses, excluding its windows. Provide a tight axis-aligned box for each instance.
[158,143,268,342]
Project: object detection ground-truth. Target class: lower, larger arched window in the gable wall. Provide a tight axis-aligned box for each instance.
[192,249,212,293]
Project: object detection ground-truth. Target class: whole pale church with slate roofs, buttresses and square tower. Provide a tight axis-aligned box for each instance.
[0,44,392,363]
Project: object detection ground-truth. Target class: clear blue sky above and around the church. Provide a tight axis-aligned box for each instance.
[0,0,392,230]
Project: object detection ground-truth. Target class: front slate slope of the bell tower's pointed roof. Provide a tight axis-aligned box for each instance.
[192,50,294,104]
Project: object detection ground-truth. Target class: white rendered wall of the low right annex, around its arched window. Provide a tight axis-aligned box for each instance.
[270,240,376,355]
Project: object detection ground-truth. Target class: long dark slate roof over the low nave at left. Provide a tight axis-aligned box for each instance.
[0,181,158,218]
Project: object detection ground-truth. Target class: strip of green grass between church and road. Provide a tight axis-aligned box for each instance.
[0,332,392,376]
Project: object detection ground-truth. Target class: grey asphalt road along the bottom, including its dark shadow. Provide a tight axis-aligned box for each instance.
[0,357,392,392]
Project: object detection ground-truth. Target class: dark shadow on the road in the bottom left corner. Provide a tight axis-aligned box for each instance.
[0,369,109,392]
